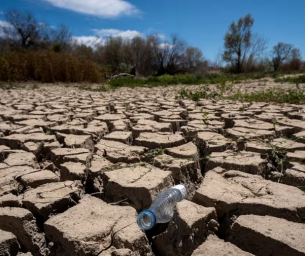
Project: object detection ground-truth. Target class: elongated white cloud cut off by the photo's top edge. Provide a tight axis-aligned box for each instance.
[44,0,140,18]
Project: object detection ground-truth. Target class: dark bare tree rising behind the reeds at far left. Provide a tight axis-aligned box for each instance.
[3,10,47,48]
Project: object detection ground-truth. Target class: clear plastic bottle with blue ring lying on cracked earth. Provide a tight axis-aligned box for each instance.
[137,184,187,230]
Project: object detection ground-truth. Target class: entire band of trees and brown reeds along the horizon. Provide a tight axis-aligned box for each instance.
[0,10,304,82]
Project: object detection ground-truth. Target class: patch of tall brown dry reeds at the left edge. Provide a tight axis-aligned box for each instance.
[0,50,103,83]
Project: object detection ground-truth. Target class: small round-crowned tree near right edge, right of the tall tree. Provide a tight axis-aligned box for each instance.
[271,42,293,71]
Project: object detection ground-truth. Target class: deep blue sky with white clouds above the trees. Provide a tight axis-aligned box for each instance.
[0,0,305,61]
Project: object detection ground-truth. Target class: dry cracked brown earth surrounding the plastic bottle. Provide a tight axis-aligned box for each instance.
[0,82,305,256]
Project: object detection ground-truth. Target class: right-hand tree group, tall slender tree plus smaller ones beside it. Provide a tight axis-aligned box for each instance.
[222,14,304,73]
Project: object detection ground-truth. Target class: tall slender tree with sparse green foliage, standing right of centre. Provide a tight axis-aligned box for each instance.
[223,14,254,73]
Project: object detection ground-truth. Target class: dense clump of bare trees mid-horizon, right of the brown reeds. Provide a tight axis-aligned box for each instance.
[73,31,207,77]
